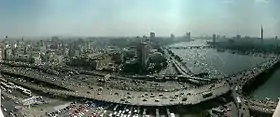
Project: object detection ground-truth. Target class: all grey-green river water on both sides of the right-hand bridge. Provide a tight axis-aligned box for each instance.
[170,40,280,100]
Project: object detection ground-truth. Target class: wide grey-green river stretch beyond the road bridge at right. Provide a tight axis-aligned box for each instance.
[168,40,266,78]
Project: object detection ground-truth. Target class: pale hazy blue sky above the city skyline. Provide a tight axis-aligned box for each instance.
[0,0,280,37]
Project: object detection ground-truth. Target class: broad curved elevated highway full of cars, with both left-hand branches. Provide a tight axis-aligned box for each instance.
[0,65,230,106]
